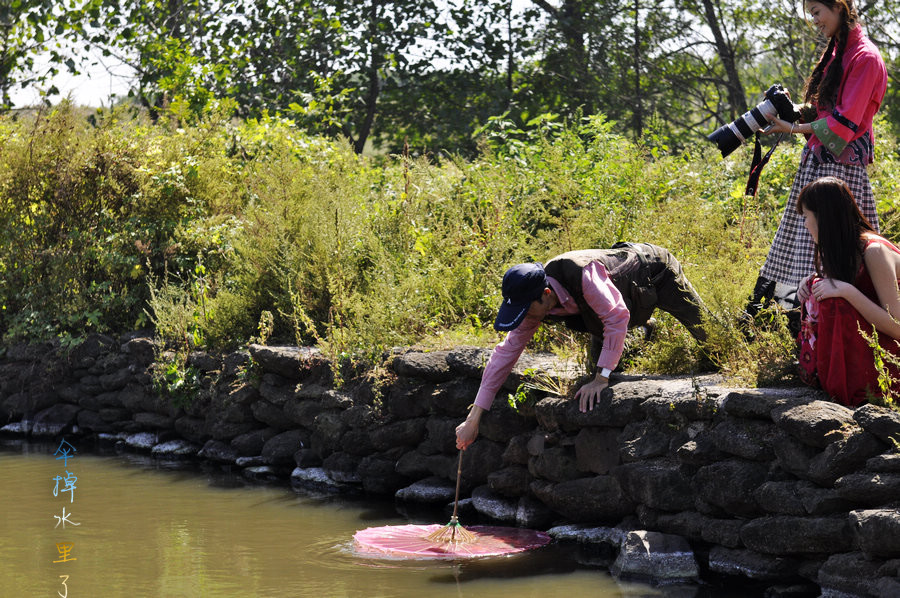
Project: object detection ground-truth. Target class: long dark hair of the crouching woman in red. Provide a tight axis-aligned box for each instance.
[797,176,875,284]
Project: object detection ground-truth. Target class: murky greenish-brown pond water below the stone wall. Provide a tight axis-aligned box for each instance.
[0,441,733,598]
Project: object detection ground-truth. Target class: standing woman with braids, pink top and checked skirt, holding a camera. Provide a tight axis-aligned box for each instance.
[748,0,884,315]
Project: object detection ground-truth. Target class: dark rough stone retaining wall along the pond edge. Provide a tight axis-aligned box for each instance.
[0,334,900,597]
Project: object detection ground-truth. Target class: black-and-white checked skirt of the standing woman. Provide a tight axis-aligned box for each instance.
[759,152,878,287]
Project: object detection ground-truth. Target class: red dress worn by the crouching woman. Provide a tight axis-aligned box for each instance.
[800,237,900,407]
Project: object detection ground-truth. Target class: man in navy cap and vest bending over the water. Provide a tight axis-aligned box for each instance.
[456,243,706,449]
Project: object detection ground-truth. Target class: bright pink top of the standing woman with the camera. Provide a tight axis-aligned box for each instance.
[807,25,887,166]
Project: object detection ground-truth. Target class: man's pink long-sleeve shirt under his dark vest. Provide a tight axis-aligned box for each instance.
[475,261,631,409]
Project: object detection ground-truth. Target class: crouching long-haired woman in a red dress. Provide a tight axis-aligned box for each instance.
[797,177,900,406]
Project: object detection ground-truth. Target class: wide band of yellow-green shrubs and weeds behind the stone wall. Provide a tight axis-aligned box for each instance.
[0,103,898,388]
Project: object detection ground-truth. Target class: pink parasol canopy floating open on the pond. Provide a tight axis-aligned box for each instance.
[353,524,550,559]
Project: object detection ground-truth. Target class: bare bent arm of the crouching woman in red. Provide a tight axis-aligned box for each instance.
[813,244,900,339]
